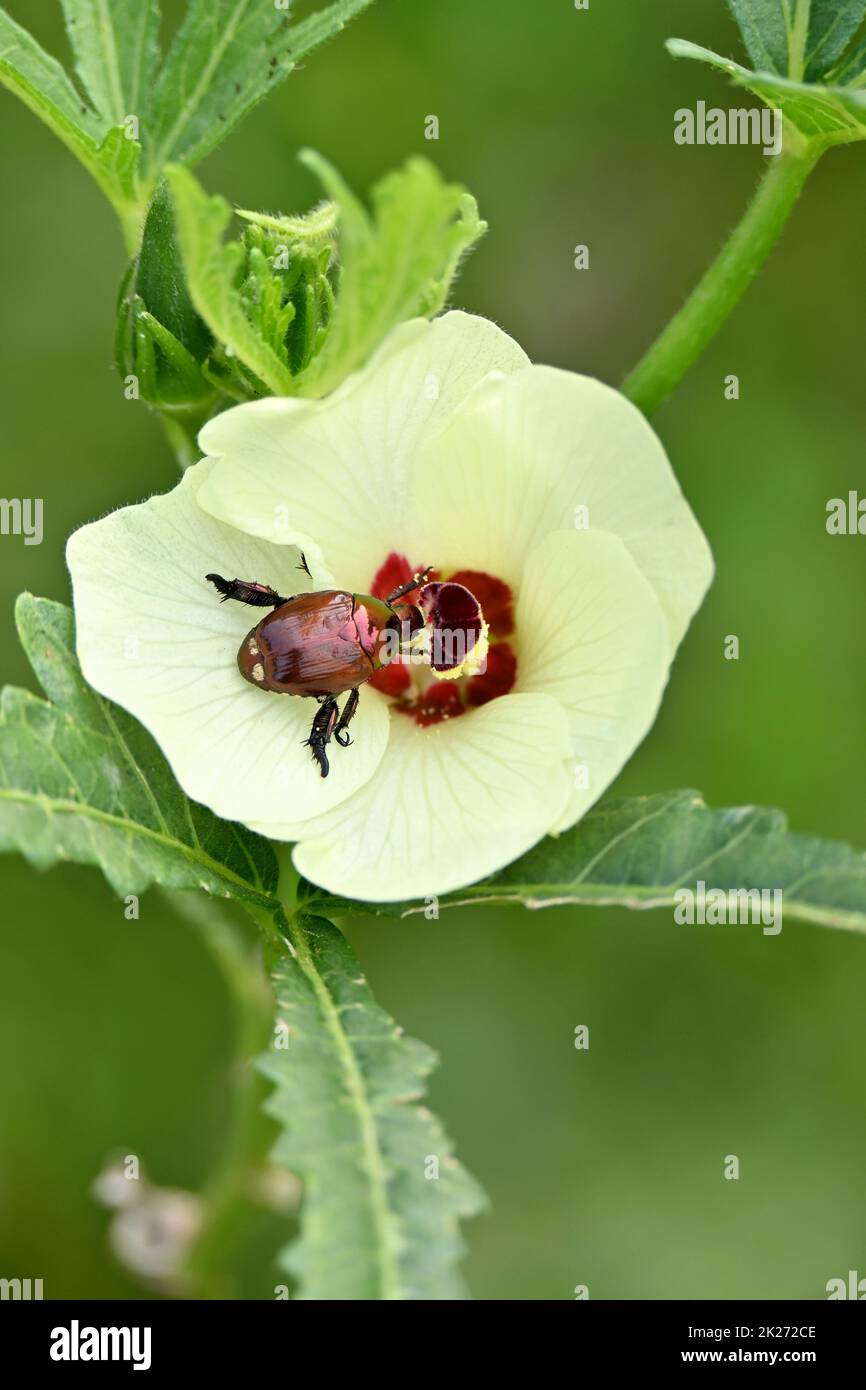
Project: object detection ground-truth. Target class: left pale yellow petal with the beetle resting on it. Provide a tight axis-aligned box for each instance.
[67,463,388,823]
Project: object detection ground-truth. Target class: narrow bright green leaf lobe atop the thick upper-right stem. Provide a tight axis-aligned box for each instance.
[667,39,866,145]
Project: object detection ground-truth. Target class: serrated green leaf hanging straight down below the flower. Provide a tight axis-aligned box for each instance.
[260,916,482,1300]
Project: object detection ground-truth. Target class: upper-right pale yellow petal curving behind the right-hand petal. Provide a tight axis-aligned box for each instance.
[413,367,713,648]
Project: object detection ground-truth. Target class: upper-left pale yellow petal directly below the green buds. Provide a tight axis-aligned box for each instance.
[199,313,527,592]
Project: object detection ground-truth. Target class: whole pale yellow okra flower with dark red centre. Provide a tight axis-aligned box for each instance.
[68,313,712,901]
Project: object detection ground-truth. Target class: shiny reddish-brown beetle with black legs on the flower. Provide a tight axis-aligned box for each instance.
[206,555,430,777]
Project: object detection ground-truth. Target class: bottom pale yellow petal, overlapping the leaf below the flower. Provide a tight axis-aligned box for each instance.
[271,695,571,902]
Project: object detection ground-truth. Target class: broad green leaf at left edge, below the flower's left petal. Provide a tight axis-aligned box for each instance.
[0,594,277,905]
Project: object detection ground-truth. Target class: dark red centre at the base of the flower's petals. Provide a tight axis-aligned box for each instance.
[370,550,517,728]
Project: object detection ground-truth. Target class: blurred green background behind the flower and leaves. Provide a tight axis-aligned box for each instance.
[0,0,866,1300]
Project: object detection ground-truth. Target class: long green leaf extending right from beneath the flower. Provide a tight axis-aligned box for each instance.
[304,791,866,931]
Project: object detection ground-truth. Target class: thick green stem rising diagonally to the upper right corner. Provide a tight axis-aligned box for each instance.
[623,134,826,416]
